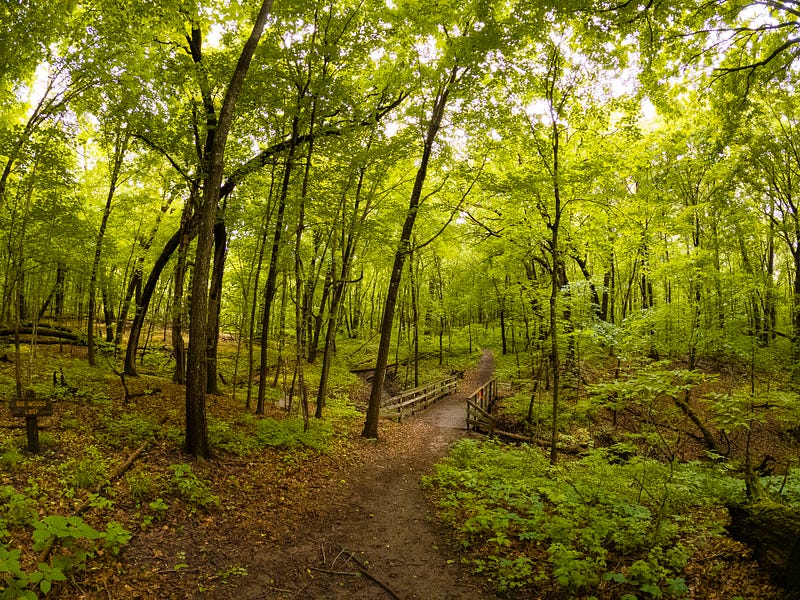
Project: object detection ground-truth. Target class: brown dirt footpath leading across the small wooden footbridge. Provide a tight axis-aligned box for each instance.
[223,352,494,600]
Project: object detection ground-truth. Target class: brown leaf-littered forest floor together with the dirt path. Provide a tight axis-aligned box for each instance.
[0,344,780,600]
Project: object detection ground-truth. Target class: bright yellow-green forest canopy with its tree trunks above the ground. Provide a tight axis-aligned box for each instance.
[0,1,800,446]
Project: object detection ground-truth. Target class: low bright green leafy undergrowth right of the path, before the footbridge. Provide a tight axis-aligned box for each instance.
[432,440,744,597]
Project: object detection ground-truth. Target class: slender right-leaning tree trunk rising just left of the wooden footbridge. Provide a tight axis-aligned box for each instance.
[361,67,458,438]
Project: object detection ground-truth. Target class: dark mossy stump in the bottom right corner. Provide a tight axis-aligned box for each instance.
[727,499,800,598]
